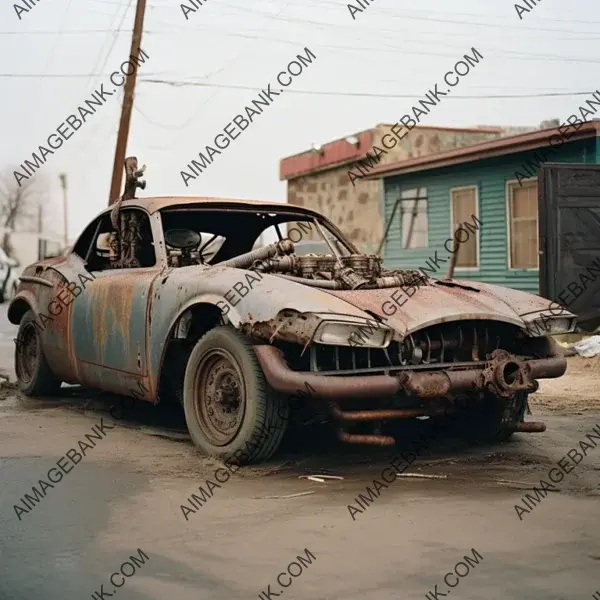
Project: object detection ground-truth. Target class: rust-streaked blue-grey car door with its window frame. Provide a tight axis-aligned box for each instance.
[70,209,161,398]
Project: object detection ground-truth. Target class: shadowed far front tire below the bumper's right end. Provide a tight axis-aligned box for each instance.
[460,392,527,443]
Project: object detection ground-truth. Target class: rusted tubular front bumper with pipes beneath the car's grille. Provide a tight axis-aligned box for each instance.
[254,345,567,446]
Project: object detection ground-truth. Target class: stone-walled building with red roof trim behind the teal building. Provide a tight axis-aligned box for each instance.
[280,124,506,251]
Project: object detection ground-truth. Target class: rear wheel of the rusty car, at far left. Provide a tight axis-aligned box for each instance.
[15,310,62,396]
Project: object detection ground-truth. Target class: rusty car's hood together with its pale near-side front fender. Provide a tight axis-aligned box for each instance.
[153,265,568,340]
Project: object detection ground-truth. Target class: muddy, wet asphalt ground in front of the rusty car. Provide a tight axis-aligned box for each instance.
[0,307,600,600]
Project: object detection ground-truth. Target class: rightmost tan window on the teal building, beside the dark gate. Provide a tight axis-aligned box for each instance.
[508,181,539,269]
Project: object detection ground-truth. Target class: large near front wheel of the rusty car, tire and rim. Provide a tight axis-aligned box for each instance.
[183,326,289,465]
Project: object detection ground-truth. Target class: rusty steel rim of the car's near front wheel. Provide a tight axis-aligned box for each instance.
[194,348,246,446]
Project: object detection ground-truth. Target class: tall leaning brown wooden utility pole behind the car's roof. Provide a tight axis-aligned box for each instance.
[108,0,146,206]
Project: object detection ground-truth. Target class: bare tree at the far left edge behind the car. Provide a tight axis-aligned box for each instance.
[0,169,40,257]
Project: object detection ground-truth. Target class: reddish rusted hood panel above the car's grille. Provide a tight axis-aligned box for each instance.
[327,280,549,336]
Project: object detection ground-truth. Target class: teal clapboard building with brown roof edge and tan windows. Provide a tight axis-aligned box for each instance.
[368,121,600,293]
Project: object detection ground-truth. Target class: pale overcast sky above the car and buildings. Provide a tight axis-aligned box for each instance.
[0,0,600,238]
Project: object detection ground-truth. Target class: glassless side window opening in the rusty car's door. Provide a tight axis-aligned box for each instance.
[87,209,156,271]
